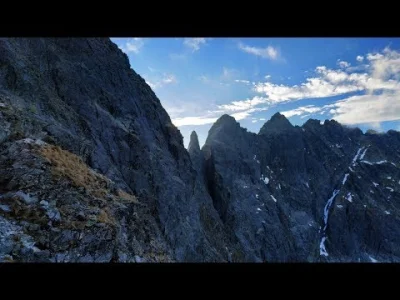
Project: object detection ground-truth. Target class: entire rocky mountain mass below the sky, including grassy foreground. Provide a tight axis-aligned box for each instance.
[0,38,400,262]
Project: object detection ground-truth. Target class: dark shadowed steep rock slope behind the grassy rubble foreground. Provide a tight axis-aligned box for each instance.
[0,38,240,261]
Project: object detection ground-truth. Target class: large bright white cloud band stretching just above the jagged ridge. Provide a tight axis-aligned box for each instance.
[175,48,400,127]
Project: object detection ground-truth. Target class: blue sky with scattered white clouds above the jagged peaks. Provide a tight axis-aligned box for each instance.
[111,38,400,147]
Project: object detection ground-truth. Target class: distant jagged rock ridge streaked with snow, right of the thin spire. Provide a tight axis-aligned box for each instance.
[202,113,400,261]
